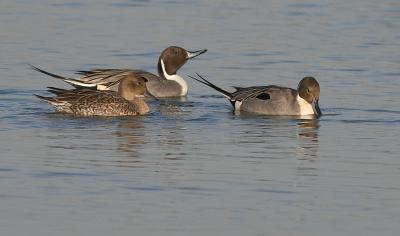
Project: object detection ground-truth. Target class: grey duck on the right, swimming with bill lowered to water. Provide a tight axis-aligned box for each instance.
[190,74,322,117]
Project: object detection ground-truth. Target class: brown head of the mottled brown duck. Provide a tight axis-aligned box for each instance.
[118,75,147,100]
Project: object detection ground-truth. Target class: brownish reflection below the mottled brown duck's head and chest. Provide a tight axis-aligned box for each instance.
[115,119,146,157]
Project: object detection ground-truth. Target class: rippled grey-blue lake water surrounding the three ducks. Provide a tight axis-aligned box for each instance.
[0,0,400,236]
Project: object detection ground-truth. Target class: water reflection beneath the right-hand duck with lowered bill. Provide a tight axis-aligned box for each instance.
[230,115,320,161]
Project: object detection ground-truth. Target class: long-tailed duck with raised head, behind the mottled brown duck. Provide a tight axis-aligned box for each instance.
[32,46,207,98]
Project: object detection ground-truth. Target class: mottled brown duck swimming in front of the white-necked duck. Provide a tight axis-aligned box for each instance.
[35,76,149,116]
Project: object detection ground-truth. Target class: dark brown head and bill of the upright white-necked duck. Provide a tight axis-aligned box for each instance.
[158,46,207,78]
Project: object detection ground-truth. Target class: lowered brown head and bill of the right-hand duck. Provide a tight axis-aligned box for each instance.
[297,76,322,117]
